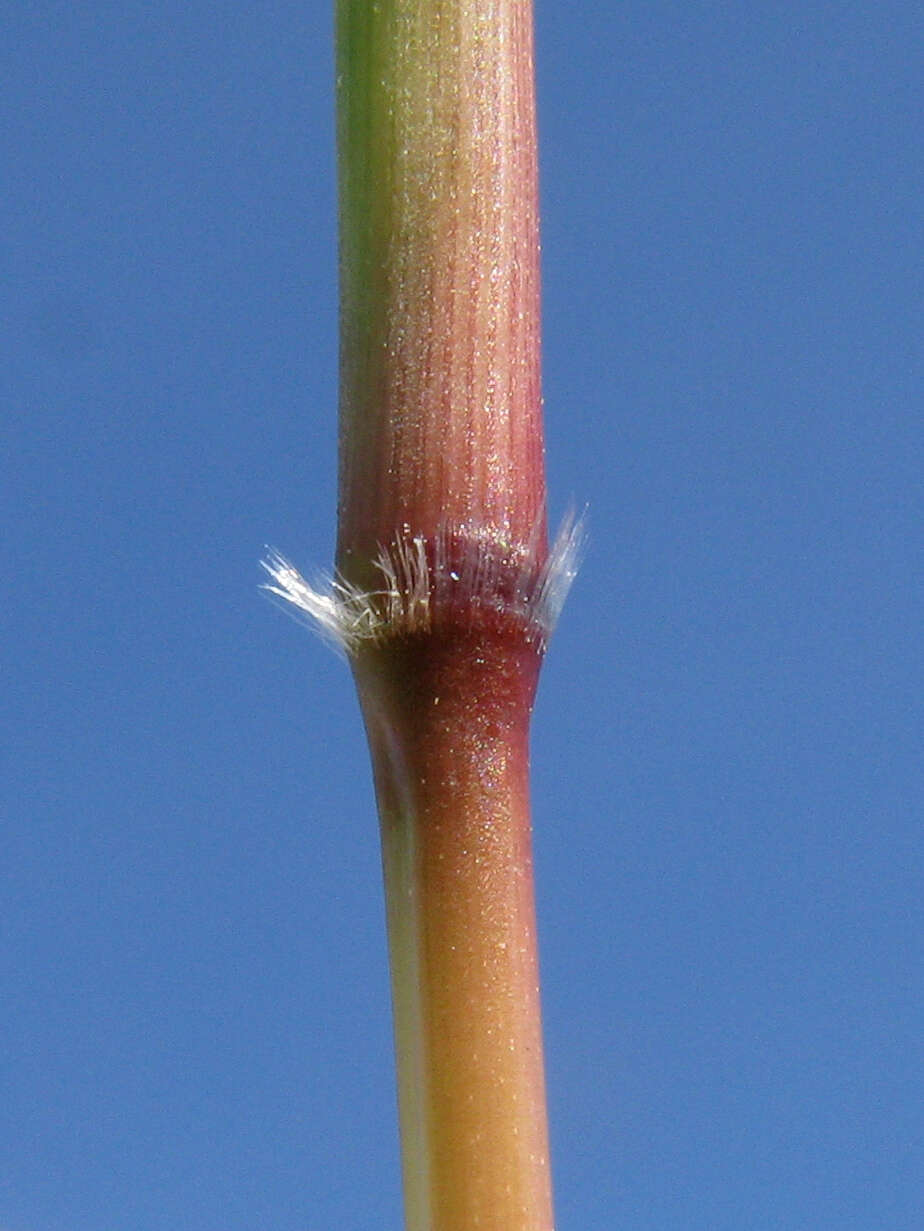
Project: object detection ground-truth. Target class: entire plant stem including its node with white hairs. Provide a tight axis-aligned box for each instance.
[266,0,578,1231]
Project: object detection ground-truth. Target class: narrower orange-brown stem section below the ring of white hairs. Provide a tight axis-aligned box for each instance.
[354,632,552,1231]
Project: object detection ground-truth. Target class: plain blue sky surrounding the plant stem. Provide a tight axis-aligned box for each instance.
[0,0,924,1231]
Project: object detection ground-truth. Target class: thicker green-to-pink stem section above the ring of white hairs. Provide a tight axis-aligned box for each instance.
[337,0,545,588]
